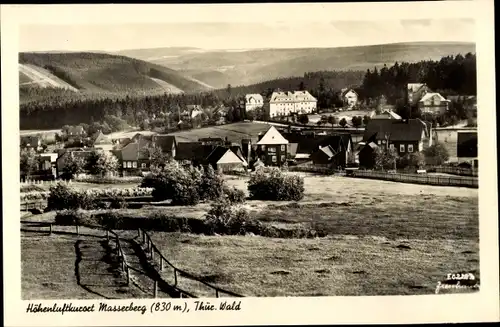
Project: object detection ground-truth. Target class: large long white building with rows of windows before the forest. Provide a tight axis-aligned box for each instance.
[269,91,318,117]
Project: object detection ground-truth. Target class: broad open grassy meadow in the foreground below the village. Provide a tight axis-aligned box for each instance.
[23,173,479,297]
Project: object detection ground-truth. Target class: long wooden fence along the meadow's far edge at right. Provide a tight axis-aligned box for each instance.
[351,170,479,188]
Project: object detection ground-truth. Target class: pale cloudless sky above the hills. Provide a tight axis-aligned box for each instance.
[19,18,476,51]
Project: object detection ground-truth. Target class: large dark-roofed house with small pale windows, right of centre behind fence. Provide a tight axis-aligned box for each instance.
[359,119,432,167]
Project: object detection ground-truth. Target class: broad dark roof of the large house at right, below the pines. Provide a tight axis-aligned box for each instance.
[363,119,428,141]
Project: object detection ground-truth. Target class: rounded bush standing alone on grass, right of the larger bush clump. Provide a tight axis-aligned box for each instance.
[248,168,304,201]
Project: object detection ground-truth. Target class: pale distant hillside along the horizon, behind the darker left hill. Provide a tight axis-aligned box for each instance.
[120,42,475,88]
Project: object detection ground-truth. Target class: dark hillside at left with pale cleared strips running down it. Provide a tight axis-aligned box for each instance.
[19,52,211,102]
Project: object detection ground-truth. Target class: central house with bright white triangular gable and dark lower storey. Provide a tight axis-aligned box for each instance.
[256,126,288,166]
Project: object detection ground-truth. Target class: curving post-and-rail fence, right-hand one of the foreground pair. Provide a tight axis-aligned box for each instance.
[138,228,243,298]
